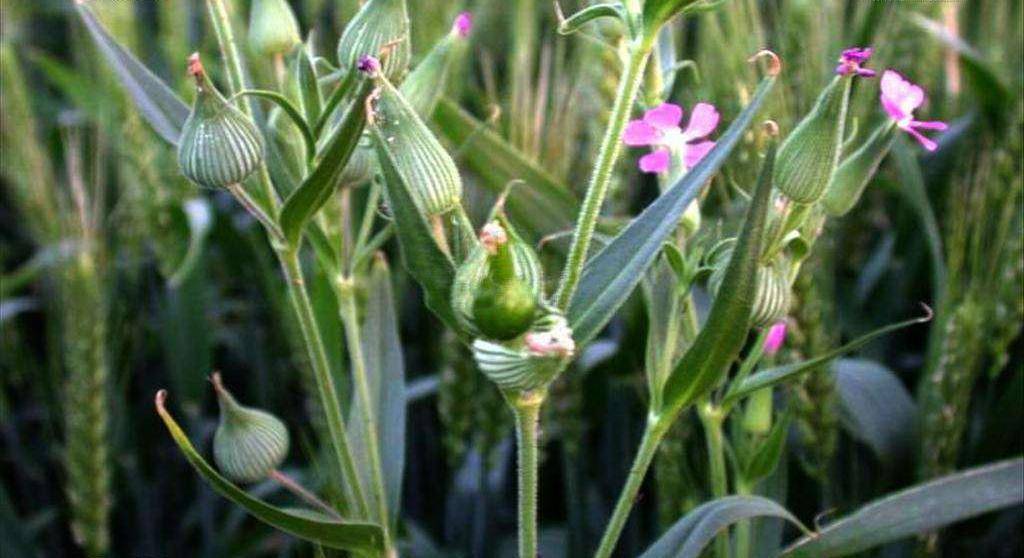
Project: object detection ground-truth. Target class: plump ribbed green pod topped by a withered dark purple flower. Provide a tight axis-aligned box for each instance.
[775,76,851,204]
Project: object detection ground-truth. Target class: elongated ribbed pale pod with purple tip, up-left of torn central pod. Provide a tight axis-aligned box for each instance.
[368,69,462,216]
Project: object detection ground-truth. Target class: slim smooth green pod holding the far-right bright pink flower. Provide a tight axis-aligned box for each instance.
[821,120,896,217]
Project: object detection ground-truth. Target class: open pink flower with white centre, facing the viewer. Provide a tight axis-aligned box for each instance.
[623,102,719,173]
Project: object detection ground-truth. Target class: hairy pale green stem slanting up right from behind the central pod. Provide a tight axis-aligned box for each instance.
[555,38,651,310]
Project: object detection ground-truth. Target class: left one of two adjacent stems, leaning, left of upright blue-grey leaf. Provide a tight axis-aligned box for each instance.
[278,249,368,517]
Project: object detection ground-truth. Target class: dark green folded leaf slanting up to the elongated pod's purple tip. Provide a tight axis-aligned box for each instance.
[281,80,372,246]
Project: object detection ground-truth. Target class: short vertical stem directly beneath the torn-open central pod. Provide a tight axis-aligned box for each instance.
[510,391,547,558]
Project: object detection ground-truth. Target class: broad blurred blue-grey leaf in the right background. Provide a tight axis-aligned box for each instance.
[833,358,918,465]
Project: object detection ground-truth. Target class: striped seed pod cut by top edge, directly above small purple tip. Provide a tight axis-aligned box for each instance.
[338,0,410,83]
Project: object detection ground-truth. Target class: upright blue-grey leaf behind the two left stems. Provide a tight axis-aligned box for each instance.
[348,259,406,525]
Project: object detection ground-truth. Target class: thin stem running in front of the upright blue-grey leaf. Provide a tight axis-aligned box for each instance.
[337,277,391,548]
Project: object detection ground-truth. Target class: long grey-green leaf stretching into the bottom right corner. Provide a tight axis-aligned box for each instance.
[781,459,1024,558]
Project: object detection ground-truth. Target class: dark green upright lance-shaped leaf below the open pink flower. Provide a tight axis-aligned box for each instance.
[662,136,775,418]
